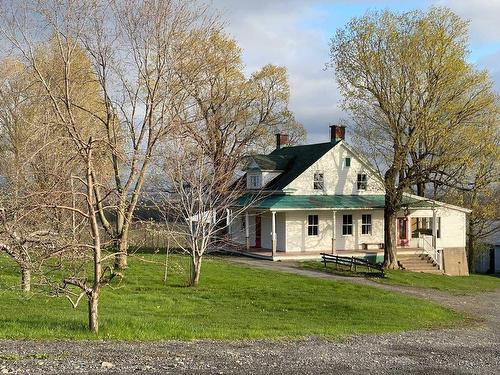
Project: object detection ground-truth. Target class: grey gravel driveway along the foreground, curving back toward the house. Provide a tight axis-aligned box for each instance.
[0,259,500,374]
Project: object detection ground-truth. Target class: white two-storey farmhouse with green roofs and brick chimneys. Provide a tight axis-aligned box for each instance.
[229,126,469,274]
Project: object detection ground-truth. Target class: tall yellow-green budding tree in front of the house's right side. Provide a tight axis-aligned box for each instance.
[331,8,497,267]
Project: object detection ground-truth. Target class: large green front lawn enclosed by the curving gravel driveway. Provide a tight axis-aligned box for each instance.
[0,254,467,340]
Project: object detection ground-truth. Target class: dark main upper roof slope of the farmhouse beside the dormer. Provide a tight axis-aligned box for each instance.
[259,142,339,190]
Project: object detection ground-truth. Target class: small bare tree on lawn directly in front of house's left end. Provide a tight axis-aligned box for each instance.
[161,139,259,286]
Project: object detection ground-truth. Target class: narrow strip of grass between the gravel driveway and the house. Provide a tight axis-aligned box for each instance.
[301,261,500,294]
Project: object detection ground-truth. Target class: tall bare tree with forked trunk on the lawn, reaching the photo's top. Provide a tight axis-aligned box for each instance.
[77,0,218,268]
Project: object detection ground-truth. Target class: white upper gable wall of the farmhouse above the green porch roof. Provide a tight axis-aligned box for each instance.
[285,144,384,195]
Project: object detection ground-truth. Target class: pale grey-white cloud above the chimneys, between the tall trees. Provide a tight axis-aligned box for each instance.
[214,0,340,142]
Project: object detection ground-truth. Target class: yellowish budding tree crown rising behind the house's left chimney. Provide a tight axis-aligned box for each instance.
[177,31,305,173]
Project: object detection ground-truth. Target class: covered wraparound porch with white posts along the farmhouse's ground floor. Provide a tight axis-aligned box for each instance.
[230,195,458,266]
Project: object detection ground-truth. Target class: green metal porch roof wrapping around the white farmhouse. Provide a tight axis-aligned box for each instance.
[238,194,432,210]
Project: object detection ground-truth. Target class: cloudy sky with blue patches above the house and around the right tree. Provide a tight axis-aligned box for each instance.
[212,0,500,143]
